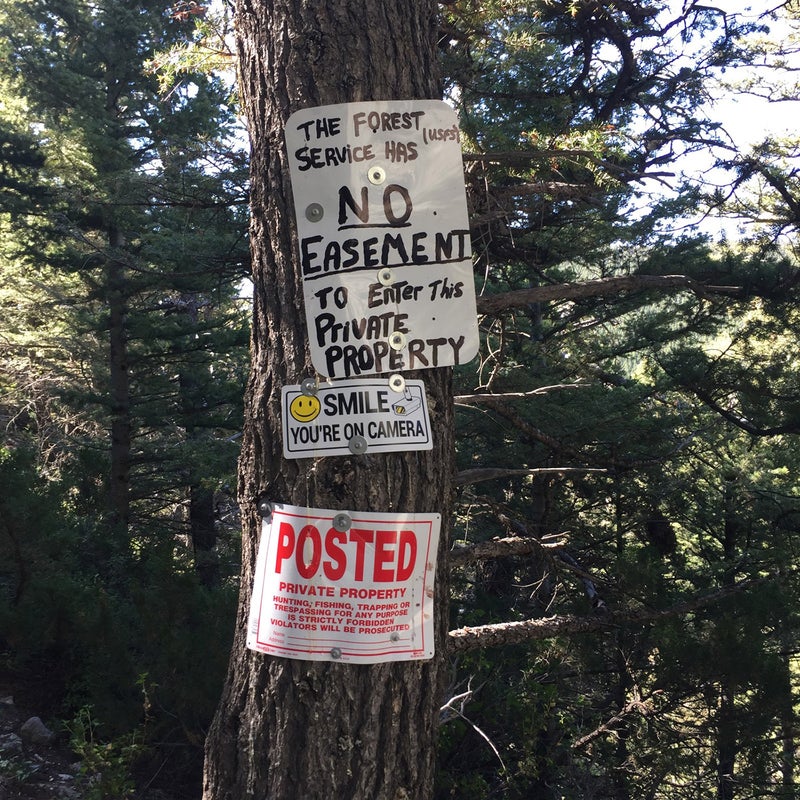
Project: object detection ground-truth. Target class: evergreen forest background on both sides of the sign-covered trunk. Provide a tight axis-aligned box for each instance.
[0,0,800,800]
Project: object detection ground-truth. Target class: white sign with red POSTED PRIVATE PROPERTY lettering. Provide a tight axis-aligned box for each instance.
[247,505,441,664]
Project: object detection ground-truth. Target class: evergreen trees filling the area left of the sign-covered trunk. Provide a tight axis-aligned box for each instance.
[0,0,248,776]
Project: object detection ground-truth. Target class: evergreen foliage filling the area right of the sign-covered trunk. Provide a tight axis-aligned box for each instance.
[439,2,800,800]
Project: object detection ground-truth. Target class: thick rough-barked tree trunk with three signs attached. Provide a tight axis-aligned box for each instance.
[204,0,453,800]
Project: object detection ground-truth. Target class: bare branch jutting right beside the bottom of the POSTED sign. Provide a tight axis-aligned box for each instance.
[447,578,767,653]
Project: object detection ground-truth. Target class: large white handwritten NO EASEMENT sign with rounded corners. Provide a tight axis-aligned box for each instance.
[286,100,478,378]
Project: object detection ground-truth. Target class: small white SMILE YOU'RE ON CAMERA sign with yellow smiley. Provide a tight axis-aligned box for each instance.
[282,378,433,458]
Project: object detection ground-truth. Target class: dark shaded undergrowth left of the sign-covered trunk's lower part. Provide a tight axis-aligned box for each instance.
[0,451,236,746]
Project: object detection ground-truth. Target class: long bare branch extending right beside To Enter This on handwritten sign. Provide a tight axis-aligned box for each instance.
[478,275,742,314]
